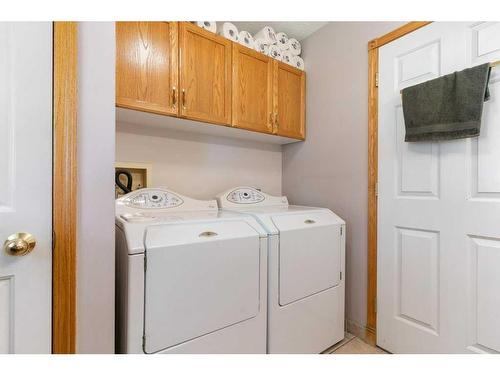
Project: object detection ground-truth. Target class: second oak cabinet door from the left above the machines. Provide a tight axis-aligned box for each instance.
[179,22,232,125]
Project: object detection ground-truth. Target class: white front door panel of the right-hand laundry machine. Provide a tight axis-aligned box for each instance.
[272,211,341,306]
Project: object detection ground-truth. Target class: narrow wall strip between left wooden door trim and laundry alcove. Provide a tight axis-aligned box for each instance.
[77,22,115,353]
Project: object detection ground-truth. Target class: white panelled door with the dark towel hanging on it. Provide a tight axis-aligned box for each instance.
[377,22,500,353]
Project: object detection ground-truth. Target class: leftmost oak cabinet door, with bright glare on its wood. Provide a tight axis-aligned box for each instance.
[116,22,178,115]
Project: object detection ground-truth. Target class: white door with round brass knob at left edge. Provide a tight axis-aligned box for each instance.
[0,22,52,354]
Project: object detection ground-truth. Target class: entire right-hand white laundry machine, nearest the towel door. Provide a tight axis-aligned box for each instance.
[217,187,345,353]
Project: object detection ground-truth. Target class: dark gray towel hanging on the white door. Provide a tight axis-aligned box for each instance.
[402,64,491,142]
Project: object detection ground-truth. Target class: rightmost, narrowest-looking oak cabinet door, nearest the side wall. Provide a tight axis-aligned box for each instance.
[274,62,306,139]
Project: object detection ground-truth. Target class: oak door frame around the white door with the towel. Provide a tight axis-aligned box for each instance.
[365,21,431,345]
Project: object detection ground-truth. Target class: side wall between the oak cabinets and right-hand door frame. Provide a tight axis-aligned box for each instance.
[283,22,404,333]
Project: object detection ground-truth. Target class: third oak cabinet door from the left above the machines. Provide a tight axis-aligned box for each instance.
[233,43,273,133]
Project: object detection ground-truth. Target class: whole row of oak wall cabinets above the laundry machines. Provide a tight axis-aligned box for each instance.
[116,22,305,140]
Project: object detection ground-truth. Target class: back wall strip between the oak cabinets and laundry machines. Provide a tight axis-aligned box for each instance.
[116,120,282,199]
